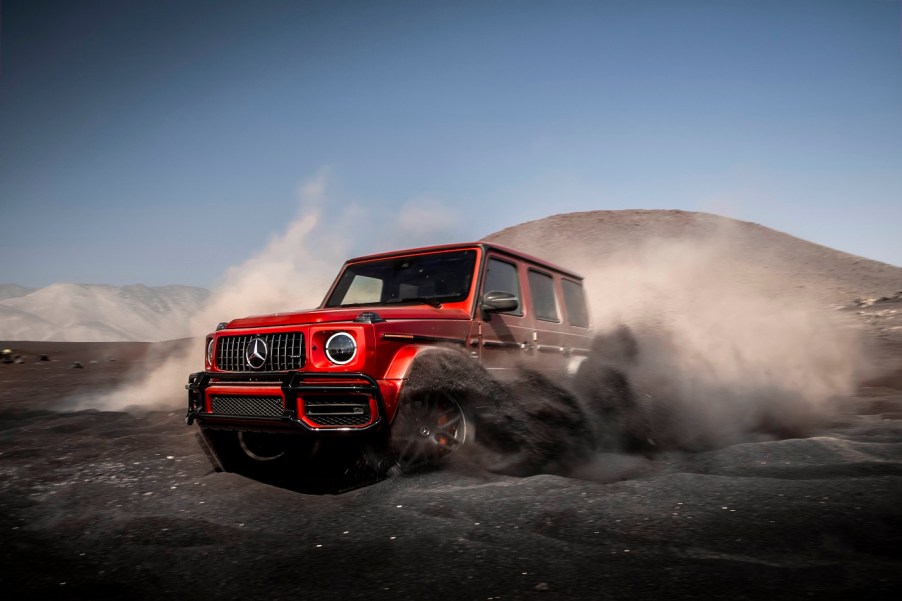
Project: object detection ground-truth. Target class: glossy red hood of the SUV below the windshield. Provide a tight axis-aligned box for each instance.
[228,305,470,329]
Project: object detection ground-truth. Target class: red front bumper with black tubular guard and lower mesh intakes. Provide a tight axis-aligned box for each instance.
[185,371,386,434]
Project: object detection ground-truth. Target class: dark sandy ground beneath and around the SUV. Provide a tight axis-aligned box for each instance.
[0,342,902,600]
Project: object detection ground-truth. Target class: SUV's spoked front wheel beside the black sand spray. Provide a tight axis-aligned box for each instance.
[392,393,472,471]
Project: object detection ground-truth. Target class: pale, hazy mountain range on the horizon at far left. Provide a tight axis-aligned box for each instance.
[0,284,210,342]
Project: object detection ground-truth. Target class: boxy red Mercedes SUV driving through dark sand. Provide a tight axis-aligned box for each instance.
[186,242,590,471]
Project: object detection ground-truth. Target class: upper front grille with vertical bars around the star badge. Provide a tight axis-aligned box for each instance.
[216,332,304,372]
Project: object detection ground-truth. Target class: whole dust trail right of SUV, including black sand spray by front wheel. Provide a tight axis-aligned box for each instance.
[402,231,867,482]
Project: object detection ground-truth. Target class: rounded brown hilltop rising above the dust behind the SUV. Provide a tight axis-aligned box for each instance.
[485,210,902,307]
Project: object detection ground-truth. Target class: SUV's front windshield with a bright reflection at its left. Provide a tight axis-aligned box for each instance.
[325,250,476,307]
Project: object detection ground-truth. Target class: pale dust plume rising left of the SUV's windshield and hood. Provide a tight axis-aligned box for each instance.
[73,169,461,411]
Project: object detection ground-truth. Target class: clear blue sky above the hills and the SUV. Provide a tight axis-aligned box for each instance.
[0,0,902,287]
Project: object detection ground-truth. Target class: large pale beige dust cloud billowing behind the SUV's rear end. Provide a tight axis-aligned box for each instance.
[573,228,866,450]
